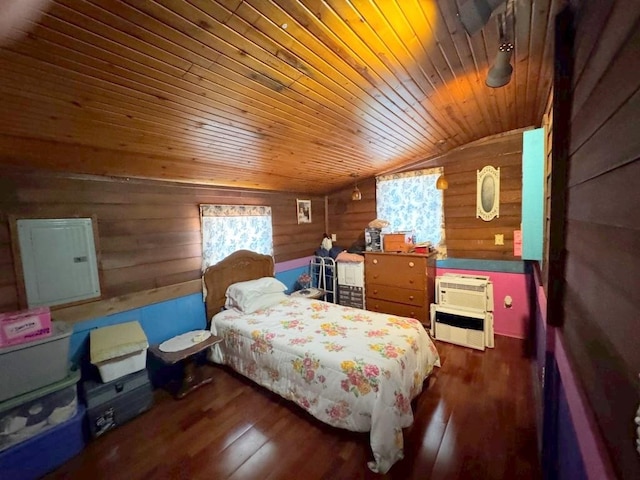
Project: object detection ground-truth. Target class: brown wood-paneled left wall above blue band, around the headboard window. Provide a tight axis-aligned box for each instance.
[0,171,325,311]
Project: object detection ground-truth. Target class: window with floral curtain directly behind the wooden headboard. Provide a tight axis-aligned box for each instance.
[200,205,273,272]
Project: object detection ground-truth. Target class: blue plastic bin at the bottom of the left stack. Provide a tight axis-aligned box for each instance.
[0,405,85,480]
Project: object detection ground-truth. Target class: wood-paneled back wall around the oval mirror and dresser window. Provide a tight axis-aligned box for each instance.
[328,130,522,260]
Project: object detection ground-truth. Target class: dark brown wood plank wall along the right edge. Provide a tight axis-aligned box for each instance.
[549,0,640,479]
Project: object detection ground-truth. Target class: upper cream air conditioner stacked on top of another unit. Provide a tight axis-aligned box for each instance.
[435,273,493,312]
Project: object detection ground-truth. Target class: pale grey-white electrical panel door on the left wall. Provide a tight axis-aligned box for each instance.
[17,218,100,308]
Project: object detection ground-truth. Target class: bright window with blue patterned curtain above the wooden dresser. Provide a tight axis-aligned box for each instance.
[376,168,444,247]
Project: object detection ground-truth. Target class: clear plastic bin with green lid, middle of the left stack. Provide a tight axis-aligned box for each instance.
[0,371,80,451]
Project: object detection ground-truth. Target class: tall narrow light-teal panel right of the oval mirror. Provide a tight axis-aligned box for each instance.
[522,128,545,261]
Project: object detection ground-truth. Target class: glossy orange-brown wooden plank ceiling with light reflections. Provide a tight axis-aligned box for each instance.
[0,0,559,194]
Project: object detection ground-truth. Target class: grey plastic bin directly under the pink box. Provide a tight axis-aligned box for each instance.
[0,321,73,402]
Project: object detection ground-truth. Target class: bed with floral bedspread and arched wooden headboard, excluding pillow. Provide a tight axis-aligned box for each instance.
[204,250,439,473]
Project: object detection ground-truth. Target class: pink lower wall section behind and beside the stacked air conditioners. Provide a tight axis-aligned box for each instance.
[436,268,531,338]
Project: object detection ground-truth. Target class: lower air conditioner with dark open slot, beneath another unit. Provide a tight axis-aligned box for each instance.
[430,303,494,350]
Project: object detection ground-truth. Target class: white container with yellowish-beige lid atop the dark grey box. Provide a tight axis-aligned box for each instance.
[89,321,149,382]
